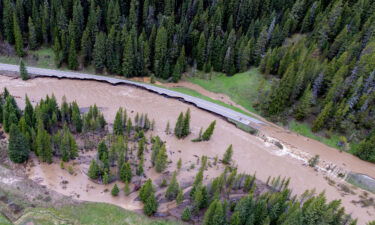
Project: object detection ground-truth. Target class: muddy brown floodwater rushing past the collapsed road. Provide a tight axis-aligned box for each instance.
[0,76,375,224]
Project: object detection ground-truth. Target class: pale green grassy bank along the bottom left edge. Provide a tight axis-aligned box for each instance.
[16,203,183,225]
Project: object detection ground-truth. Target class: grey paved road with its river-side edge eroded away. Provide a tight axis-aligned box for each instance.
[0,63,264,128]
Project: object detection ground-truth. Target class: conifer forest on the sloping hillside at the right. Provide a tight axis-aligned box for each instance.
[259,0,375,162]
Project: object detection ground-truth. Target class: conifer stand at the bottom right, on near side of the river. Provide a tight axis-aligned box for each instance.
[181,158,357,225]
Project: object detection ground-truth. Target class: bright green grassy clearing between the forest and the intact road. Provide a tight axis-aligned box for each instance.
[187,68,270,112]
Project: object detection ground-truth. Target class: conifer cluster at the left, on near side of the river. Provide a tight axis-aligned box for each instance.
[0,89,105,163]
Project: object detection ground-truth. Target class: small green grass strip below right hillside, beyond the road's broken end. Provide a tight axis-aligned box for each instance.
[289,120,340,148]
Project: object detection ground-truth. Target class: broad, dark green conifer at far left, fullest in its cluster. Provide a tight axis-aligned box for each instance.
[8,124,29,163]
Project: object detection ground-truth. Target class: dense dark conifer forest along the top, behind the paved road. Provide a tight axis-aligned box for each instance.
[0,0,312,81]
